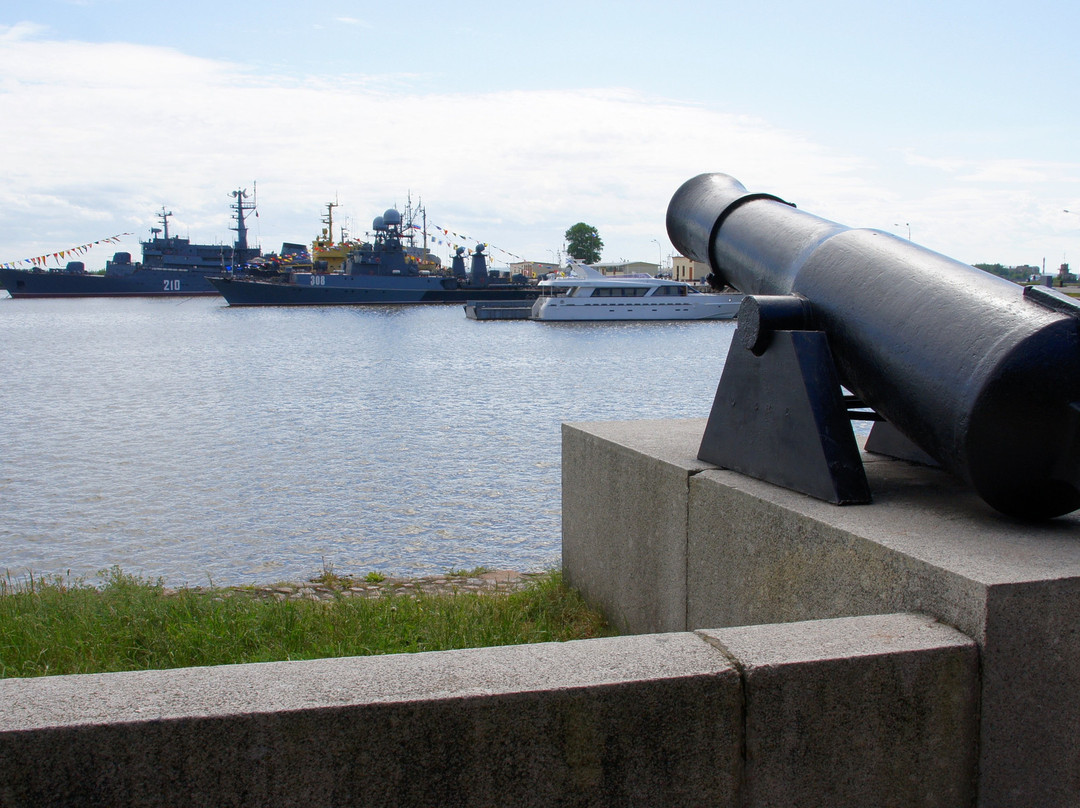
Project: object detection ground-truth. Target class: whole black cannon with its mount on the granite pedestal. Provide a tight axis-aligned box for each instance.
[667,174,1080,519]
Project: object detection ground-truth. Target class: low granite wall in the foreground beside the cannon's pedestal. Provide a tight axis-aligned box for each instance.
[0,615,977,808]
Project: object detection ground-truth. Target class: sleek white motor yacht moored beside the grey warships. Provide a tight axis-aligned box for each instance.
[529,261,743,321]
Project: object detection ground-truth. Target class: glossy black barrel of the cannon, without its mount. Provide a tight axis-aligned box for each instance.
[667,174,1080,519]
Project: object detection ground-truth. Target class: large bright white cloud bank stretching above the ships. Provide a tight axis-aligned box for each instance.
[0,33,1076,265]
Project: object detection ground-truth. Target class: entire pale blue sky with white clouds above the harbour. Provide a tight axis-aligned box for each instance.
[0,0,1080,271]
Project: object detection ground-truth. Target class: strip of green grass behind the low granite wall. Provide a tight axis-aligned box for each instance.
[0,569,612,678]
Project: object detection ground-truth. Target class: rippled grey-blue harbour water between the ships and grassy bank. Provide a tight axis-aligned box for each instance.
[0,293,734,585]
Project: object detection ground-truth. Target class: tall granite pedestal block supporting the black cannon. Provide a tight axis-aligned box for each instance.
[563,419,1080,806]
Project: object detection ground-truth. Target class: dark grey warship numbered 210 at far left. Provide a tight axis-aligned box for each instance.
[0,190,260,297]
